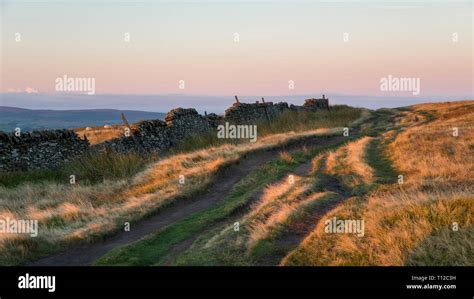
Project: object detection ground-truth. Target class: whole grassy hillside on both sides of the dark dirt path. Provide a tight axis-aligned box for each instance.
[0,101,474,266]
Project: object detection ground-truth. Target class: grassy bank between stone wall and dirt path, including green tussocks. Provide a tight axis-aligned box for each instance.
[0,106,361,265]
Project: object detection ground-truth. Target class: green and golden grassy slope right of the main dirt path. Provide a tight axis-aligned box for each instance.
[96,101,474,266]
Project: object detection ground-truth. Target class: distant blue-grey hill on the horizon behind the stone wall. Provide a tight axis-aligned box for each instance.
[0,106,166,132]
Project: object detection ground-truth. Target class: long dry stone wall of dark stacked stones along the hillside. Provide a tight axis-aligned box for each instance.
[0,97,329,171]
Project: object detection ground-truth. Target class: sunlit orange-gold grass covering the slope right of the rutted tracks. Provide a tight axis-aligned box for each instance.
[281,101,474,265]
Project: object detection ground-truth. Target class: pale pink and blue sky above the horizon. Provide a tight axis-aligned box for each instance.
[0,0,473,108]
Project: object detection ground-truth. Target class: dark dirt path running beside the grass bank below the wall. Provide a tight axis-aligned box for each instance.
[26,136,344,266]
